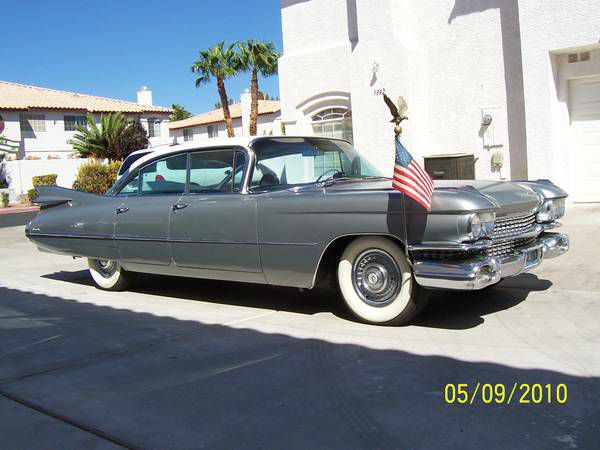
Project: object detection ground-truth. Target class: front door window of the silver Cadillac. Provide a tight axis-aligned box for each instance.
[189,150,245,193]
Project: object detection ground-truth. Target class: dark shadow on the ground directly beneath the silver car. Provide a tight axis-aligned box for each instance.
[42,270,552,330]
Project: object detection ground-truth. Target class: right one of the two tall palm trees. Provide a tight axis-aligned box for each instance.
[238,39,281,136]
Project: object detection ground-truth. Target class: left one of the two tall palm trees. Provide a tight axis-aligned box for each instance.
[192,42,239,137]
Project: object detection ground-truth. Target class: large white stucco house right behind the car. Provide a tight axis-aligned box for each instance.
[279,0,600,201]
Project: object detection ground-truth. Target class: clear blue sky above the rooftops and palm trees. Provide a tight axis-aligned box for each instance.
[0,0,282,114]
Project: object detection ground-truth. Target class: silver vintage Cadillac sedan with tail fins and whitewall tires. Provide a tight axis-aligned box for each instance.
[26,136,569,324]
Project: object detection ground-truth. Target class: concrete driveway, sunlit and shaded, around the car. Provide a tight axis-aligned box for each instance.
[0,206,600,449]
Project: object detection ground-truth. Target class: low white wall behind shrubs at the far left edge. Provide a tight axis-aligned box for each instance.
[2,158,95,202]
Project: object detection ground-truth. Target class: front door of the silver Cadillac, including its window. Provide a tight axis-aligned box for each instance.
[169,148,261,273]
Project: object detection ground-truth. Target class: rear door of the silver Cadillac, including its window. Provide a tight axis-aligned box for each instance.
[115,153,187,265]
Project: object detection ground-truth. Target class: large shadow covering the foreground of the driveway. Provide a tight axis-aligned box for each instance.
[0,284,600,450]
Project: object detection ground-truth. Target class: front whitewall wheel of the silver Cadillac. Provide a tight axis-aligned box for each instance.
[337,236,428,325]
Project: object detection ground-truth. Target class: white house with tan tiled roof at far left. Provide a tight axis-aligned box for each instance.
[0,81,171,159]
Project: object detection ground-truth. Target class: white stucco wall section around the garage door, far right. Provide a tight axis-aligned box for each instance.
[519,0,600,191]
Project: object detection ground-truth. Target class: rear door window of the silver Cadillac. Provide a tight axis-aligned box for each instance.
[140,153,187,195]
